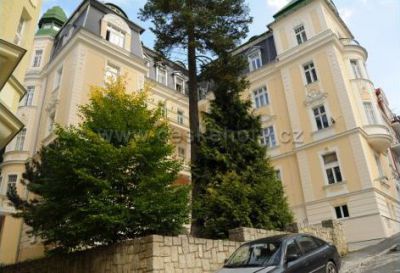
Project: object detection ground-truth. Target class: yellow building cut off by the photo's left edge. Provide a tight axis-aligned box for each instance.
[0,0,42,263]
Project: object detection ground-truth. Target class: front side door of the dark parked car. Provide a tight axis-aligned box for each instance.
[284,238,309,273]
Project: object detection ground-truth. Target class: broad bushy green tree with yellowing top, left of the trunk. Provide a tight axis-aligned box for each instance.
[8,79,189,251]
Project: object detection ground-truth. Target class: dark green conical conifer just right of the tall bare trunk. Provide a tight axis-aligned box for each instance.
[193,51,292,238]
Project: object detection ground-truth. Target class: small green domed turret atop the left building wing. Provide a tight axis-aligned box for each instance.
[36,6,67,37]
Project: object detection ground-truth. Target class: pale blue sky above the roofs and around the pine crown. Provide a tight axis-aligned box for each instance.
[42,0,400,114]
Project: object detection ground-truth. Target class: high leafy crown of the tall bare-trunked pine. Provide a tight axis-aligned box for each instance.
[141,0,252,54]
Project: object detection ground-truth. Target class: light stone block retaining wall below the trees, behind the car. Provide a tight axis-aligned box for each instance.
[0,221,347,273]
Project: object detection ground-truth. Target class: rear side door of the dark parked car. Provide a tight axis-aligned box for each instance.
[296,235,326,273]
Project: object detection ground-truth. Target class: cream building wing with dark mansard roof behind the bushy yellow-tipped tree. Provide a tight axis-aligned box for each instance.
[0,0,190,263]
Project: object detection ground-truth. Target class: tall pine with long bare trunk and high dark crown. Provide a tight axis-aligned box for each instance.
[141,0,251,234]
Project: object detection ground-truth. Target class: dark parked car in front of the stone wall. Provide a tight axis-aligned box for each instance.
[218,234,341,273]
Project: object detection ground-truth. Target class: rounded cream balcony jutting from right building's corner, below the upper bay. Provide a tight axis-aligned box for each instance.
[364,124,393,153]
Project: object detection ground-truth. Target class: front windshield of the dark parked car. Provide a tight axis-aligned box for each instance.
[224,242,281,267]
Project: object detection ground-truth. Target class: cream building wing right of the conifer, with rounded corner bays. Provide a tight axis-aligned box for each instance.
[200,0,400,249]
